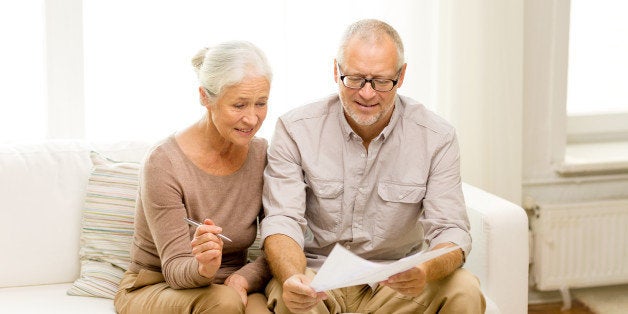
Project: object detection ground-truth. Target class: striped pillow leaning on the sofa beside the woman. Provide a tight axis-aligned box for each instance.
[68,152,140,299]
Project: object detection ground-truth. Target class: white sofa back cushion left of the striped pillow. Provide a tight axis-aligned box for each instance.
[0,140,91,287]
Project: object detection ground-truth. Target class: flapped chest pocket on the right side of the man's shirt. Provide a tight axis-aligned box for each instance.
[373,181,426,240]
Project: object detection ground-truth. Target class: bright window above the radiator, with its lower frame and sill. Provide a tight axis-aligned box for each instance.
[557,0,628,175]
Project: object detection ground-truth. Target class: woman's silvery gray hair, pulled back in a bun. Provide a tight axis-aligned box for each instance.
[192,41,273,98]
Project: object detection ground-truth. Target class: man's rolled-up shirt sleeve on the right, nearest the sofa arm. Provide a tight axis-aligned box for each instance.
[421,133,471,257]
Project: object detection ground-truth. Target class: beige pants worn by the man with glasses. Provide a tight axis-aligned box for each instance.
[266,269,486,314]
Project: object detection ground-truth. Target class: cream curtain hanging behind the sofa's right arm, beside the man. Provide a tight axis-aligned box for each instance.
[437,0,523,204]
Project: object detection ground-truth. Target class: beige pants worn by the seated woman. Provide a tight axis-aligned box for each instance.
[114,269,271,314]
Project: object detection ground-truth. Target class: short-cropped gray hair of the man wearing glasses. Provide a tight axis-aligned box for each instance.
[336,19,405,70]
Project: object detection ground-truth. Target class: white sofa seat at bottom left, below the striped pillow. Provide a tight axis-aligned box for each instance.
[0,283,115,314]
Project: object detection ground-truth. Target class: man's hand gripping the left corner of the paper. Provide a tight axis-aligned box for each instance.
[282,274,327,313]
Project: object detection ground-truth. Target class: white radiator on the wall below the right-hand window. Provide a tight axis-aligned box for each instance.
[531,200,628,291]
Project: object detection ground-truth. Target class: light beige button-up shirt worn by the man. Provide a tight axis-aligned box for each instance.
[261,95,471,269]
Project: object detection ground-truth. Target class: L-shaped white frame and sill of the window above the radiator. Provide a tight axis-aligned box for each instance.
[548,1,628,177]
